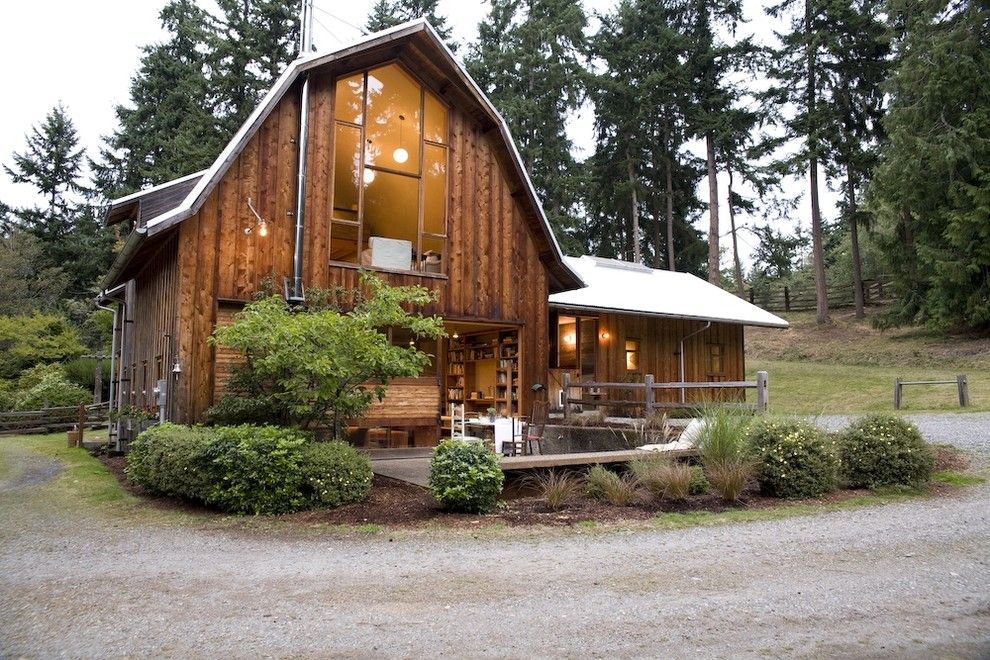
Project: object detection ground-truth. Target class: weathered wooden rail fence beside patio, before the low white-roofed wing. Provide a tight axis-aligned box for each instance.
[563,371,770,420]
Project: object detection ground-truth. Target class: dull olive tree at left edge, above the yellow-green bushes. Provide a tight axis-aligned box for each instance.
[0,228,69,316]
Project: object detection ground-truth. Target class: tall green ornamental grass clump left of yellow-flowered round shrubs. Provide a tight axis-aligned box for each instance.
[697,406,754,502]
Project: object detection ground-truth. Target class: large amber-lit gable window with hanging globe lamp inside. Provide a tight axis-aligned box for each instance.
[330,64,447,273]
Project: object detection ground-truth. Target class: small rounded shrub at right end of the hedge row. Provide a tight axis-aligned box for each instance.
[302,442,374,507]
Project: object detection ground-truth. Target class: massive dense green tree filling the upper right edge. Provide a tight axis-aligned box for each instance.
[869,0,990,330]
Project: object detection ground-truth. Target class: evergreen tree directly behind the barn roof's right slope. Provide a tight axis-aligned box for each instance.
[466,0,587,250]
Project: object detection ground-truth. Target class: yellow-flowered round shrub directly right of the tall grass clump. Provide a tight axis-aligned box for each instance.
[748,420,839,497]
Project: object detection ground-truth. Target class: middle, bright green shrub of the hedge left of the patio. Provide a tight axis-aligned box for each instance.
[207,424,308,514]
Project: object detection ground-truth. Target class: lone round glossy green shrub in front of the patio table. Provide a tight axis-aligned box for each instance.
[430,440,505,513]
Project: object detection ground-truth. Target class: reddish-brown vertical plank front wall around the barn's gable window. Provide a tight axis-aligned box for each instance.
[169,71,549,422]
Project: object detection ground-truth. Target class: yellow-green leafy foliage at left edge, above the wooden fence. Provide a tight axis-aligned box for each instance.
[0,312,86,378]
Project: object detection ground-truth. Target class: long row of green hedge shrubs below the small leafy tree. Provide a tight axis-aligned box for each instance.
[127,424,371,515]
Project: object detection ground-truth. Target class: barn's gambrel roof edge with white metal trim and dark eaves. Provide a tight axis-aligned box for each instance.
[104,19,583,291]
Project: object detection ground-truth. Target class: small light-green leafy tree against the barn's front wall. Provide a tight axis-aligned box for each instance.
[211,275,444,438]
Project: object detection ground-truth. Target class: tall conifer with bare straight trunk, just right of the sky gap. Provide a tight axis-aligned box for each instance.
[768,0,835,324]
